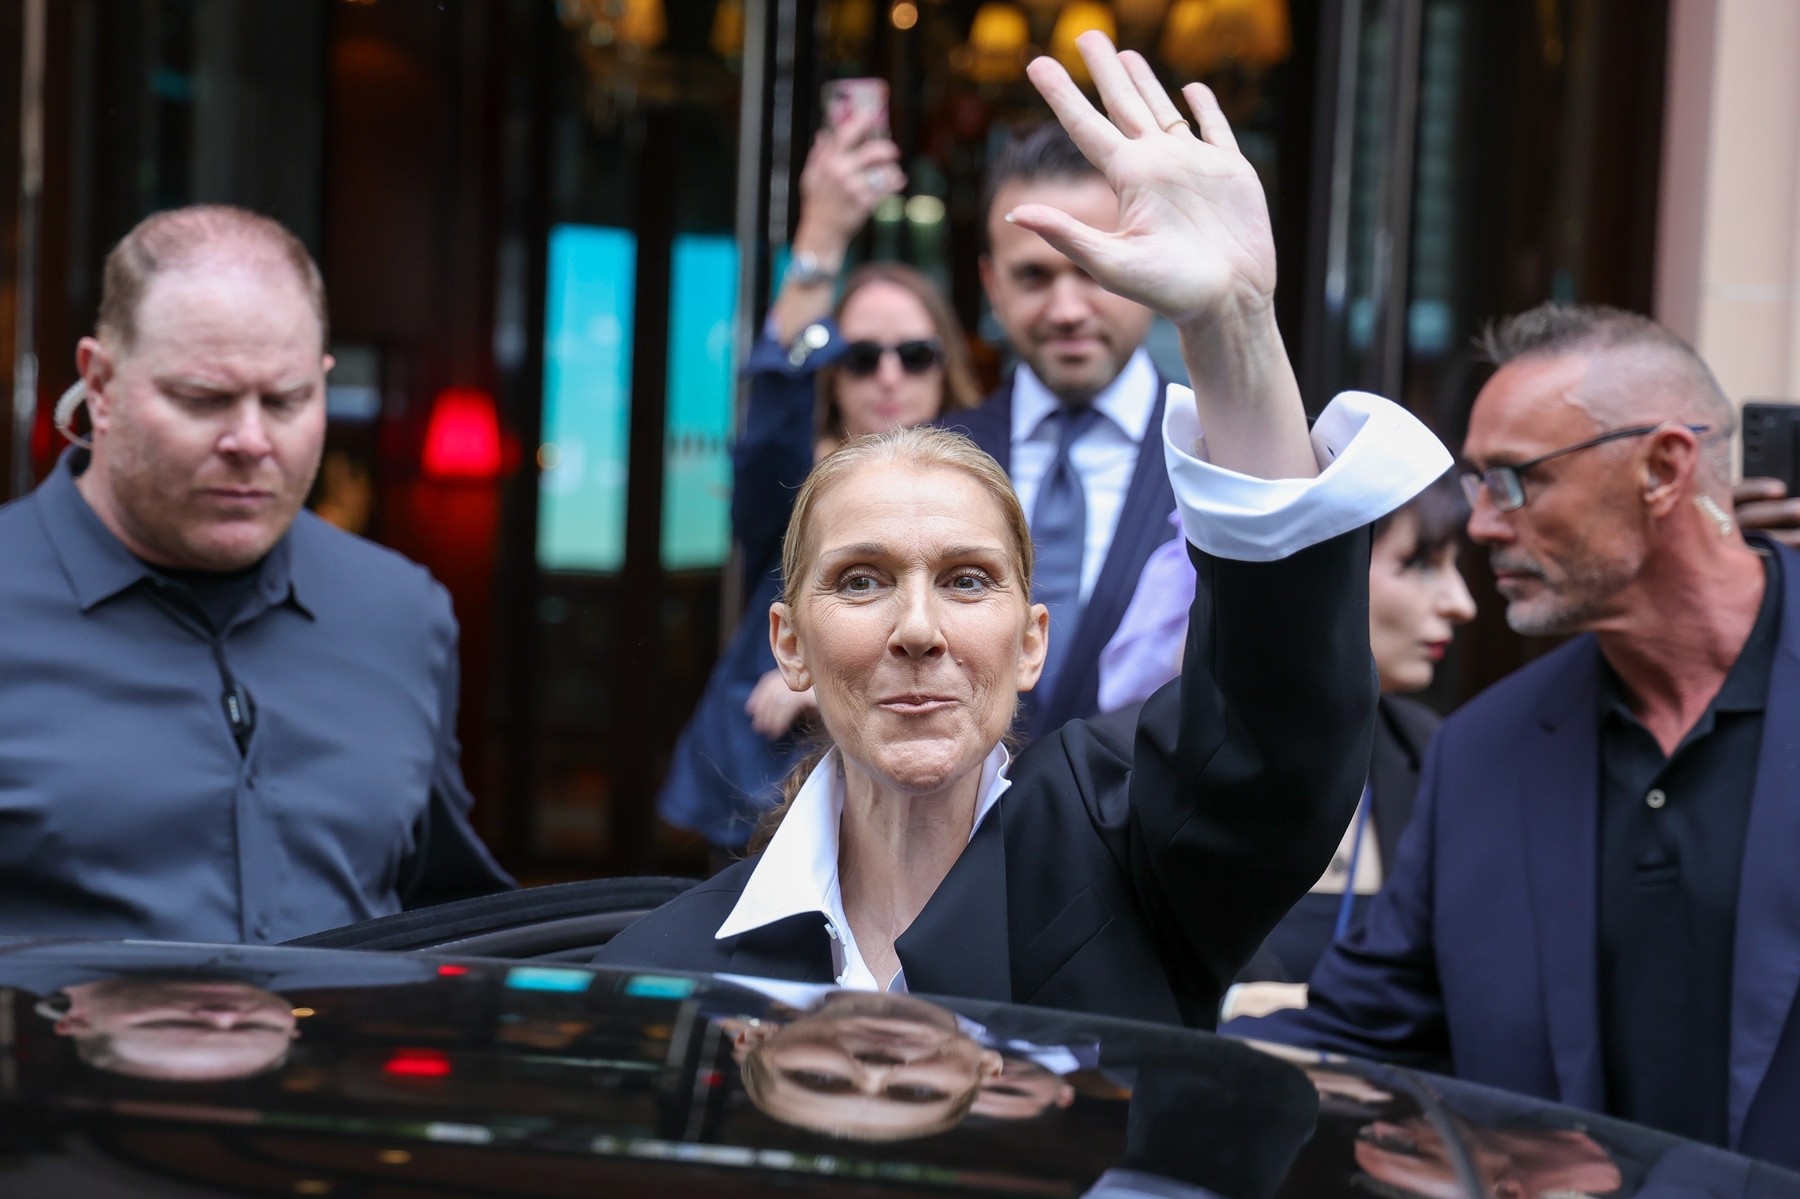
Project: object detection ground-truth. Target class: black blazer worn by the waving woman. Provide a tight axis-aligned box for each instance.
[598,529,1375,1028]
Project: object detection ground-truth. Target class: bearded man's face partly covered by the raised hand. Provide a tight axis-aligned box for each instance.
[981,176,1150,403]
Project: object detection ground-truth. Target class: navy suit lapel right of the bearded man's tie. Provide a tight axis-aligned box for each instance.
[1028,374,1175,738]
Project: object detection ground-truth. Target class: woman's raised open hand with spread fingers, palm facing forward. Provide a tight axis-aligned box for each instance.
[1008,32,1274,326]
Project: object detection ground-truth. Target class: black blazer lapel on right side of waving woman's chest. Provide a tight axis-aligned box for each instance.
[895,796,1012,1003]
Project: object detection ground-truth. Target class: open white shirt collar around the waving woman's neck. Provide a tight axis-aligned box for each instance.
[713,745,1012,940]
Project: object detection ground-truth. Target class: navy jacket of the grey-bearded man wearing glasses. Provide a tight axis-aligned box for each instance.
[1228,547,1800,1167]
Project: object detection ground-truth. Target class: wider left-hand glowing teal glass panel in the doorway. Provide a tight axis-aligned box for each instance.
[538,225,637,574]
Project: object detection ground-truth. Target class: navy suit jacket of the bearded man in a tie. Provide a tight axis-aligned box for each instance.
[943,373,1175,740]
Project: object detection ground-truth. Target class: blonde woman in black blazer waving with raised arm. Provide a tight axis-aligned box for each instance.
[601,34,1449,1026]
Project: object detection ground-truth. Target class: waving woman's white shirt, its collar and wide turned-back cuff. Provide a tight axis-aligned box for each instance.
[715,385,1451,990]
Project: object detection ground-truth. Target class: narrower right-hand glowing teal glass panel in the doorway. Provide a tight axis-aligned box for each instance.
[662,234,738,571]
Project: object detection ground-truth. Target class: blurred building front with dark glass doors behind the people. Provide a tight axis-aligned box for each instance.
[0,0,1800,880]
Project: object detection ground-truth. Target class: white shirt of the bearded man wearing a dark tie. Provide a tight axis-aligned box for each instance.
[1010,349,1156,603]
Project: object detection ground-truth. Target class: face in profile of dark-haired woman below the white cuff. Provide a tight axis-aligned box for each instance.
[1368,511,1474,691]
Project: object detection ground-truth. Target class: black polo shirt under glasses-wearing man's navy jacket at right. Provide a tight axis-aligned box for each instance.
[1598,560,1782,1145]
